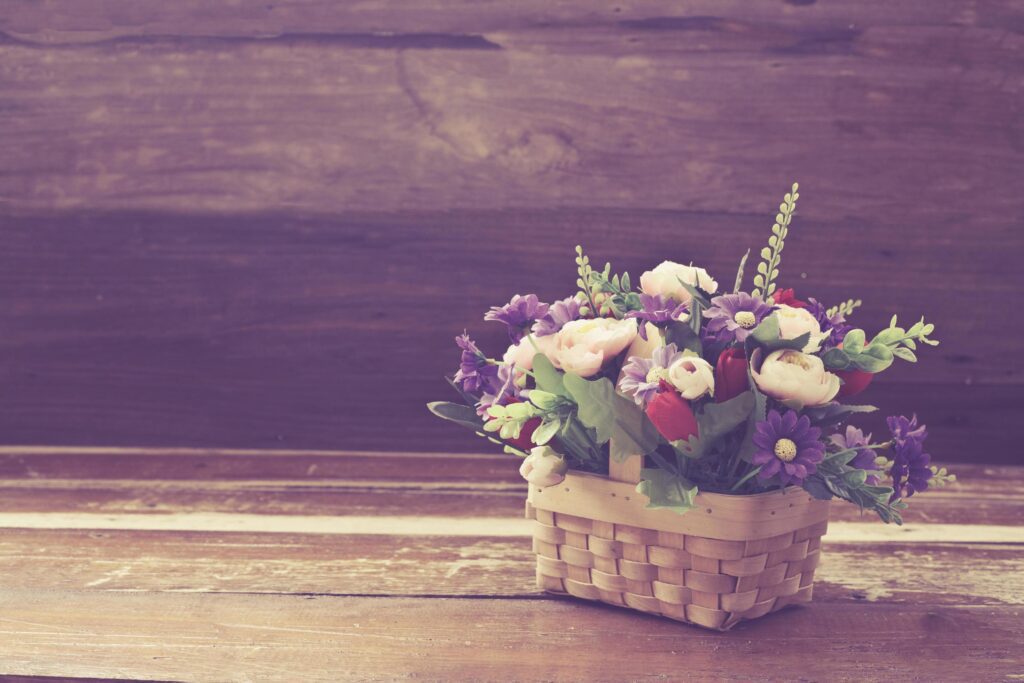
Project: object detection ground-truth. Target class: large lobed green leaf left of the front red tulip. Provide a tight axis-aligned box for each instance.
[563,373,662,462]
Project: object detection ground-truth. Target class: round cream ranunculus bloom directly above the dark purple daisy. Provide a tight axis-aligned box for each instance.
[751,348,840,405]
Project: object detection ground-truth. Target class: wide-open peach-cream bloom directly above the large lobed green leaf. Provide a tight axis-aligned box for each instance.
[541,317,637,377]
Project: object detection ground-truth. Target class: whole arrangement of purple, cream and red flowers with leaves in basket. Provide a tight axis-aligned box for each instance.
[429,184,954,523]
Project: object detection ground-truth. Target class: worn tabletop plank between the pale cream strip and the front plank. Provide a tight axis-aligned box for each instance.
[0,528,1024,604]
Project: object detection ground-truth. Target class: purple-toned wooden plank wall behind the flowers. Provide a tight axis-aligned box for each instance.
[0,0,1024,462]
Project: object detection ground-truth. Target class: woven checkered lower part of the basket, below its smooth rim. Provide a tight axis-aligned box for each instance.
[526,502,827,629]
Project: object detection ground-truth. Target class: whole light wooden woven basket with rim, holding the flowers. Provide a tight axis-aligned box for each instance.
[526,450,828,631]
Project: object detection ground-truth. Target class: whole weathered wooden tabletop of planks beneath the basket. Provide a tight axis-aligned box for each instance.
[0,447,1024,681]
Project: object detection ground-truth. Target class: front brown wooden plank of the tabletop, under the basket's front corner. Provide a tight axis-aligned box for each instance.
[0,589,1024,681]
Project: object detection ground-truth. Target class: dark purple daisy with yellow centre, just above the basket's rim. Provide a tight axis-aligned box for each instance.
[752,411,825,486]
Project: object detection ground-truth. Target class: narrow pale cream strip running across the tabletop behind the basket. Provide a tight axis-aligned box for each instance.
[0,512,1024,544]
